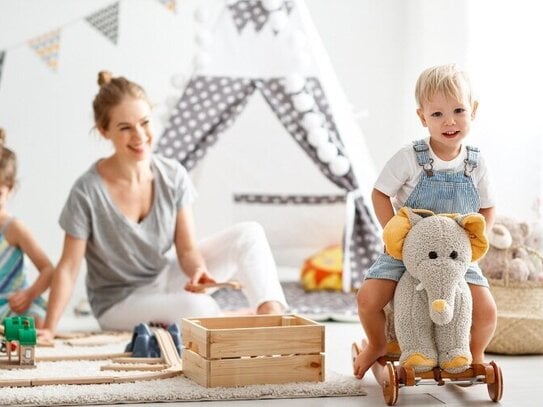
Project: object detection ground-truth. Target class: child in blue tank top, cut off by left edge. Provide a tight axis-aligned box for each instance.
[0,129,53,328]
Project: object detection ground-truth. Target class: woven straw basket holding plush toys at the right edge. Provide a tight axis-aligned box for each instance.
[486,247,543,355]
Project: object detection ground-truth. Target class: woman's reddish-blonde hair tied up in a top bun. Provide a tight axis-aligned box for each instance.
[92,71,150,129]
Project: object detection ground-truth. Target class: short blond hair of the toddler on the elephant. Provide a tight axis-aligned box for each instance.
[415,64,475,108]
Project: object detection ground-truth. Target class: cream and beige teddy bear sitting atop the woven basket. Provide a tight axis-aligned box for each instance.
[479,216,539,281]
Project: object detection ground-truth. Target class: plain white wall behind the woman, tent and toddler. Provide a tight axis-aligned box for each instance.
[0,0,543,306]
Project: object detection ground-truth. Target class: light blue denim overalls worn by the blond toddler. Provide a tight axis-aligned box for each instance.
[366,140,488,287]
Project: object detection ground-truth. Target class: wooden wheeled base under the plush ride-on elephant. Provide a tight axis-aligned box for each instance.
[352,341,503,406]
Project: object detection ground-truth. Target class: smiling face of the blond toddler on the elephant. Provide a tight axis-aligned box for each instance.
[417,93,477,148]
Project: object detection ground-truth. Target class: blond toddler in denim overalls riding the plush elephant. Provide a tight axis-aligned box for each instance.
[354,64,496,379]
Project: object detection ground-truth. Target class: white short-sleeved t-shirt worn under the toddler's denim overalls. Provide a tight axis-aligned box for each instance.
[374,137,494,210]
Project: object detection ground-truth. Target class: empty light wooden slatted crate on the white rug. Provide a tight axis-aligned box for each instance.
[181,315,324,387]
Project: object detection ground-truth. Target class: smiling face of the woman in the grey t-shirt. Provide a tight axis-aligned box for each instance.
[98,97,155,161]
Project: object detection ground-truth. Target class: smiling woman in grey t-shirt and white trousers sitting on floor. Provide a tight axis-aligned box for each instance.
[39,72,287,338]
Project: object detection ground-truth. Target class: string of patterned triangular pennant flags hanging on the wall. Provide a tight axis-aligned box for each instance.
[0,0,177,84]
